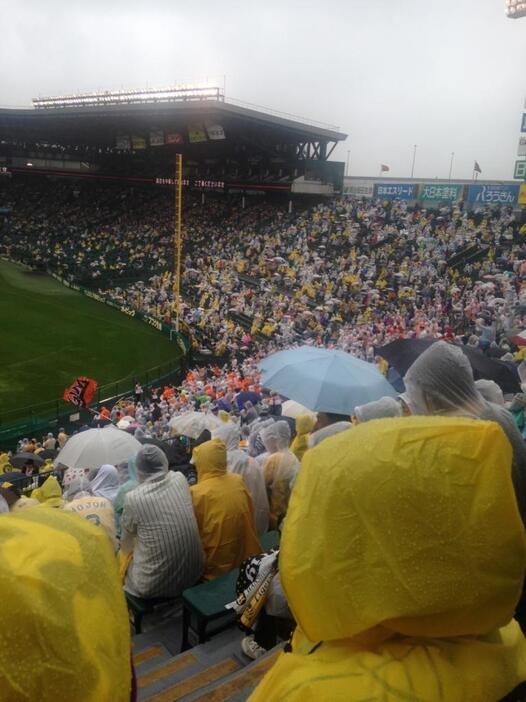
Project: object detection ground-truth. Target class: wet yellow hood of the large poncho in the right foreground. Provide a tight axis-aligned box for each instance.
[280,417,526,641]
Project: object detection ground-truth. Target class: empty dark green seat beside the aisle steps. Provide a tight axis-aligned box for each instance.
[181,531,280,651]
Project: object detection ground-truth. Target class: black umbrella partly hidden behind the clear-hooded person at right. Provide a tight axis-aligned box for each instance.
[375,339,521,393]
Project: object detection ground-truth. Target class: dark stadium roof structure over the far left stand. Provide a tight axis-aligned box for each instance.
[0,89,346,194]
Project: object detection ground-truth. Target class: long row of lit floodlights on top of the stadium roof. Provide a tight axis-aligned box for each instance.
[33,85,225,110]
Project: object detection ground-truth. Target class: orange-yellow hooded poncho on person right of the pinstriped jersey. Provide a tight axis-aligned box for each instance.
[190,439,261,580]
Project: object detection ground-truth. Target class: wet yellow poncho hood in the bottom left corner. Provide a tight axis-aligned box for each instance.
[0,509,131,702]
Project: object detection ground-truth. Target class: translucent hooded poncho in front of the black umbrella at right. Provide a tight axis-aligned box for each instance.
[404,341,526,524]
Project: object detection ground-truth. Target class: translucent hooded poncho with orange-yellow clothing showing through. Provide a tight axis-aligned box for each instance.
[261,422,300,529]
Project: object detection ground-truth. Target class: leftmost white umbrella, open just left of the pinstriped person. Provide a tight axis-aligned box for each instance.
[55,426,142,468]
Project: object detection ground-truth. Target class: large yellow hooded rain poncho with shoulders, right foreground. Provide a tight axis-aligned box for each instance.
[250,417,526,702]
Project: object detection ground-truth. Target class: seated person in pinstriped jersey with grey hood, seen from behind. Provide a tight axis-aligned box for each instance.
[121,444,204,598]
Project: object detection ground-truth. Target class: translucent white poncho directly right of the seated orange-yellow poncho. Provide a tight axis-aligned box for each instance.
[213,422,269,537]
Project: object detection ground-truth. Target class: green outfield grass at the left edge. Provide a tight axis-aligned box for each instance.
[0,261,180,417]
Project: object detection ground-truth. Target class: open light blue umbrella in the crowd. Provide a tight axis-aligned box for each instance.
[259,346,397,415]
